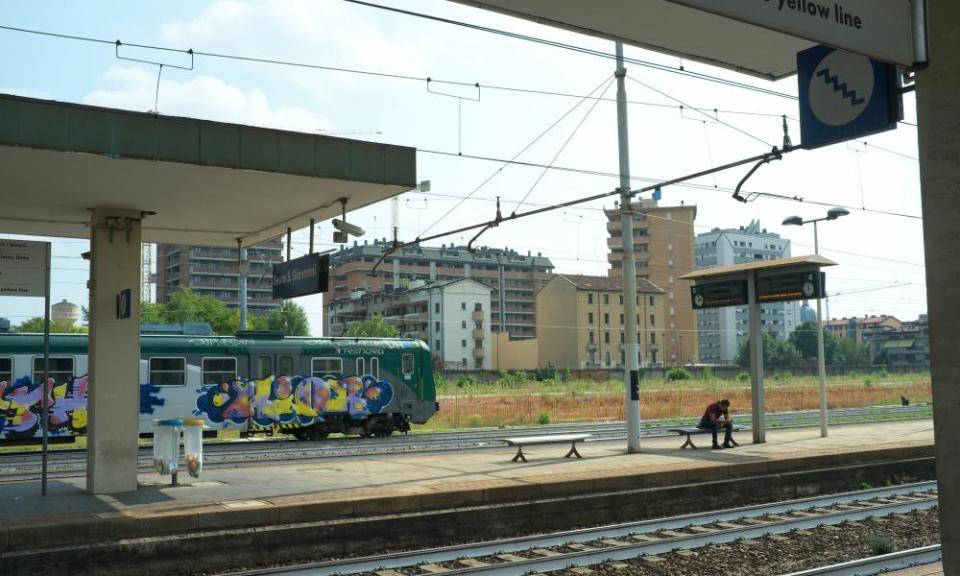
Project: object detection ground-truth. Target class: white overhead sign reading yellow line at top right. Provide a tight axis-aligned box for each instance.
[668,0,924,66]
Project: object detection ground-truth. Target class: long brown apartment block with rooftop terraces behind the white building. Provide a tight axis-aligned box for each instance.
[324,240,553,340]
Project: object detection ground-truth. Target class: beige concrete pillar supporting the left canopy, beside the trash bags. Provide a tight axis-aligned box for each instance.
[87,208,141,494]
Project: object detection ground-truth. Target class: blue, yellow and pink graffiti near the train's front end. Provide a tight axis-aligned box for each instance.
[194,375,393,428]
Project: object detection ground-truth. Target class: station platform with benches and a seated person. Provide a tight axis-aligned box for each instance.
[0,420,933,573]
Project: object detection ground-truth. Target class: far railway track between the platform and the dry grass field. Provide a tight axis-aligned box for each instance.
[0,405,930,484]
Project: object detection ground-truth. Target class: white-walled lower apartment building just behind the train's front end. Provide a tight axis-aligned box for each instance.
[324,278,492,370]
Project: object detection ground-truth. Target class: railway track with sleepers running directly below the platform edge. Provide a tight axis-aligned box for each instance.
[216,482,937,576]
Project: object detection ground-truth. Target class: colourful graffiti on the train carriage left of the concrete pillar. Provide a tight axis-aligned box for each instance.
[0,376,89,440]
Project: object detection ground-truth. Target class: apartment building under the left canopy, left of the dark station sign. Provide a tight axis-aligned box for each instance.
[157,240,283,314]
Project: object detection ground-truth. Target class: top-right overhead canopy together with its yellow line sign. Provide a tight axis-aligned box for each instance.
[452,0,916,80]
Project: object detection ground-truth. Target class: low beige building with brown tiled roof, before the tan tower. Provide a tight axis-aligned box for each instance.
[537,274,666,369]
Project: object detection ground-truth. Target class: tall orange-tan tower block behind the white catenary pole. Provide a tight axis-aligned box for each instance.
[606,200,699,365]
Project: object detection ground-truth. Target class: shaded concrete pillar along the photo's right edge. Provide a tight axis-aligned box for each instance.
[917,1,960,576]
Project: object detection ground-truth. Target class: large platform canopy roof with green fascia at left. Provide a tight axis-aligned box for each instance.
[0,94,417,247]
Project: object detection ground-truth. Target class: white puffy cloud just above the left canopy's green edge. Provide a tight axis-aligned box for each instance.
[83,66,332,132]
